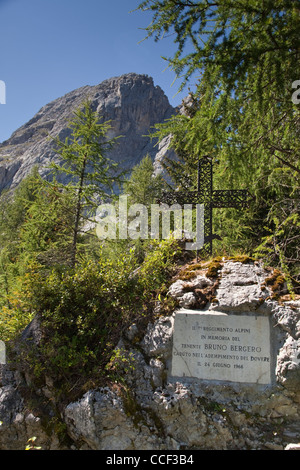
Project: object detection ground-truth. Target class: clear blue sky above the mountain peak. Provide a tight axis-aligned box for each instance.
[0,0,192,142]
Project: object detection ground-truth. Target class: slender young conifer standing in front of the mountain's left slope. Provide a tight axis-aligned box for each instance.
[51,101,123,267]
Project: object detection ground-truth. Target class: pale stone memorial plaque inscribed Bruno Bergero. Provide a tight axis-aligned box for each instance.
[171,309,271,384]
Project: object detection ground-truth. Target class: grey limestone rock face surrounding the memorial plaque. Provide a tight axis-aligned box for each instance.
[0,261,300,450]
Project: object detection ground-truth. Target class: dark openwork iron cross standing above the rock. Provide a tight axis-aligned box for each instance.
[160,156,251,257]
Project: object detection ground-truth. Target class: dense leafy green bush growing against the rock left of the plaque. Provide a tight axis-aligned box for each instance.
[0,240,178,382]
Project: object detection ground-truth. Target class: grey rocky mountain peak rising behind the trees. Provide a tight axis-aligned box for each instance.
[0,73,175,191]
